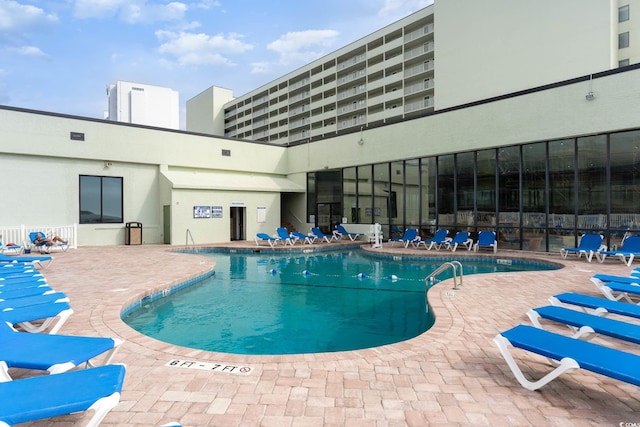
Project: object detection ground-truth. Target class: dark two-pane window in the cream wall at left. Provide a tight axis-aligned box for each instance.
[80,175,123,224]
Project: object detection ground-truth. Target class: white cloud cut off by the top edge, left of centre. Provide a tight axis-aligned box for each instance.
[73,0,188,24]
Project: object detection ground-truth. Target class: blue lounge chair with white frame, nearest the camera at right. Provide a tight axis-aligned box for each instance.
[494,325,640,390]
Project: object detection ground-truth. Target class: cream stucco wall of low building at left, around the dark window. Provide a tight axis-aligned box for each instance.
[0,109,286,246]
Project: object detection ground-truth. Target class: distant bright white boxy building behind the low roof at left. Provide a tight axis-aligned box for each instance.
[106,80,180,129]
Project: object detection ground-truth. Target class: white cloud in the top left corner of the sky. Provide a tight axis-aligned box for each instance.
[0,0,58,40]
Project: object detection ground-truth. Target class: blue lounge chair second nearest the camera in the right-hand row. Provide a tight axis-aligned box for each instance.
[527,305,640,344]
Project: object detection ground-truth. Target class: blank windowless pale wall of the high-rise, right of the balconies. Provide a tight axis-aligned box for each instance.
[434,0,617,110]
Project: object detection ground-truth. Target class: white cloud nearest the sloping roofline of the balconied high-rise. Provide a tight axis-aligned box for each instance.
[267,30,339,65]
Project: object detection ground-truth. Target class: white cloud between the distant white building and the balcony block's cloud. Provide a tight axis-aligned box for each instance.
[156,30,253,66]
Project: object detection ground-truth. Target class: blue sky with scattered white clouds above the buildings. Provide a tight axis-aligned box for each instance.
[0,0,433,128]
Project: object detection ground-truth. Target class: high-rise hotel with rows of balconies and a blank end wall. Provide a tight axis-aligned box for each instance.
[187,0,640,145]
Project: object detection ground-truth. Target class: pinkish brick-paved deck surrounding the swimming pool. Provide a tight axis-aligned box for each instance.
[13,242,640,427]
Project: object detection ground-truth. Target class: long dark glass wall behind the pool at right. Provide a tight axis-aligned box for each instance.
[307,126,640,252]
